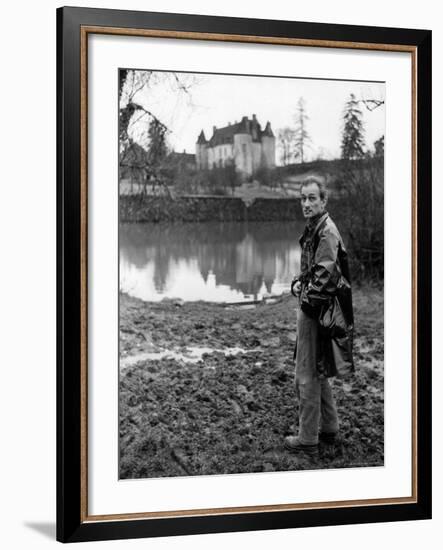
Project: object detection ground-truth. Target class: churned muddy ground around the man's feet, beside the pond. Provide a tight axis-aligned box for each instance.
[120,287,384,479]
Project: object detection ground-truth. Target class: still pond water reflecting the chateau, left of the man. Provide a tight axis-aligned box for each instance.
[120,222,302,302]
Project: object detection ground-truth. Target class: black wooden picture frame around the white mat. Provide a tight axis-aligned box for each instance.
[57,8,431,542]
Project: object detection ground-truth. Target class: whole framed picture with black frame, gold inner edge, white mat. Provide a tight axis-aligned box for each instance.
[57,8,431,542]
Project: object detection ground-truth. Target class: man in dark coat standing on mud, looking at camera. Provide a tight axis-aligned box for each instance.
[284,178,354,456]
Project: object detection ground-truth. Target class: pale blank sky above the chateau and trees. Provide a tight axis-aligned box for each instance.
[123,71,385,164]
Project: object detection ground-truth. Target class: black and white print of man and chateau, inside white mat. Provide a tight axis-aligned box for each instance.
[118,68,386,479]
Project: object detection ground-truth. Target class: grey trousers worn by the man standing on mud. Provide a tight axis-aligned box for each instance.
[295,309,339,445]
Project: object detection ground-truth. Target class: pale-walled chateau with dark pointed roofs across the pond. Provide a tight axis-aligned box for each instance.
[195,115,275,176]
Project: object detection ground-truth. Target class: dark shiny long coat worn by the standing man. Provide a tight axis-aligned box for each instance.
[296,212,354,377]
